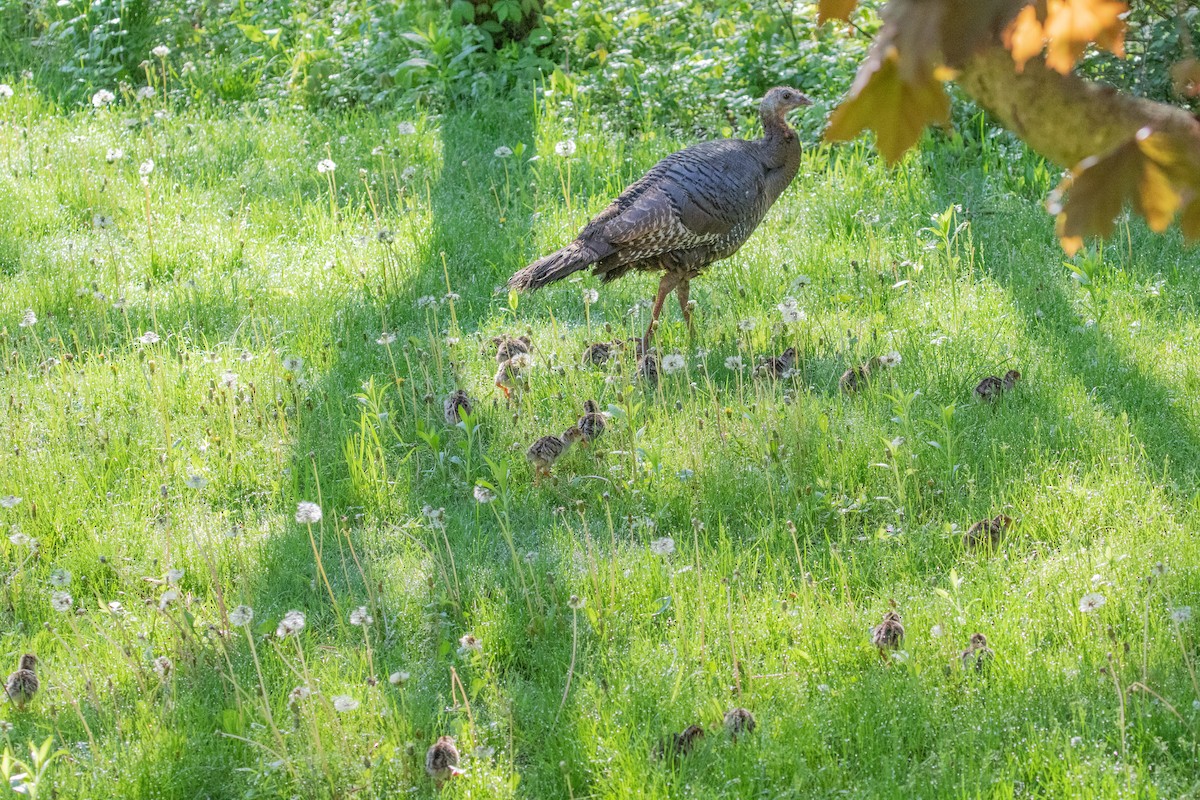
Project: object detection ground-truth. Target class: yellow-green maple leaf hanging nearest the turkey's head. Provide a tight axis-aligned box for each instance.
[824,48,950,164]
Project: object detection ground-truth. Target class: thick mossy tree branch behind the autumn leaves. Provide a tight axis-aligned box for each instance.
[956,46,1200,167]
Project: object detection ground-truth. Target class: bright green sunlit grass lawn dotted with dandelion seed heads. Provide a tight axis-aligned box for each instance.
[0,76,1200,798]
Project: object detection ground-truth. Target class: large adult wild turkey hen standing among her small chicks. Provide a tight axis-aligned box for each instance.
[509,86,812,349]
